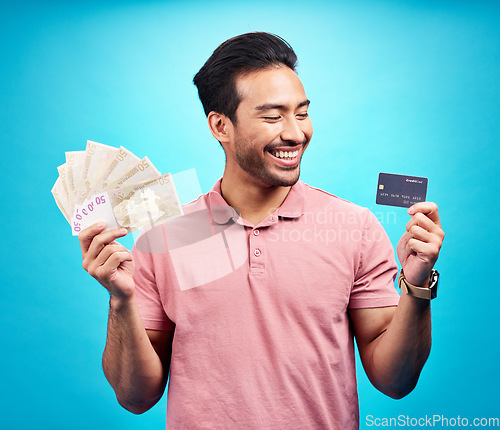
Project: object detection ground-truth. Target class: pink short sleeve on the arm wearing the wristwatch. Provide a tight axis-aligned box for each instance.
[349,209,399,309]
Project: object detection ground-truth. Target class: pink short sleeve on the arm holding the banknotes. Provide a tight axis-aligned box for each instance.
[132,235,175,330]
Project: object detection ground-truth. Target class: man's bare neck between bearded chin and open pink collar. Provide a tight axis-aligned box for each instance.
[221,166,291,225]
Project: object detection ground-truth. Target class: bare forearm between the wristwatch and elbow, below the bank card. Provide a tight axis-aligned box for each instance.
[365,294,431,398]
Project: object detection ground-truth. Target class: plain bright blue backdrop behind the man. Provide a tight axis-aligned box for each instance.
[0,0,500,430]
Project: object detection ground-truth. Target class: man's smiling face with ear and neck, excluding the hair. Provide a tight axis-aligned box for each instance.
[208,64,312,225]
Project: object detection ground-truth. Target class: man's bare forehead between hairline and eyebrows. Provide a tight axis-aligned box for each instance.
[235,66,307,109]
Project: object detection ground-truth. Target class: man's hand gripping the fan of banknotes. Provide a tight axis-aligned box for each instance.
[78,223,135,299]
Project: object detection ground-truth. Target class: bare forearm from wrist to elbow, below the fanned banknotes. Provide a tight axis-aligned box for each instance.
[102,297,166,413]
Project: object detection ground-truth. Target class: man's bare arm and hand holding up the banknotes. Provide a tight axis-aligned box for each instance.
[79,224,174,414]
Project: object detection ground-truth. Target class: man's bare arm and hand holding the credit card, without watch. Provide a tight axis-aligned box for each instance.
[349,202,444,398]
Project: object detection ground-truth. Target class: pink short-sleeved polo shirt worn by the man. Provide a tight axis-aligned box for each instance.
[133,181,399,430]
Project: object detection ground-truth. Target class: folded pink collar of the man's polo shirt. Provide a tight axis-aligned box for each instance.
[208,178,305,224]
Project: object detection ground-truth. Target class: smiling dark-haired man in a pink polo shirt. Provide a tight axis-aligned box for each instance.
[80,32,444,429]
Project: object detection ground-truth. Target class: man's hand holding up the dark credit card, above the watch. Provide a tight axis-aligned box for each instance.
[397,202,444,286]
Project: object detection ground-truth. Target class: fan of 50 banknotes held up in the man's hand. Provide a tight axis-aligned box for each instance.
[52,140,182,236]
